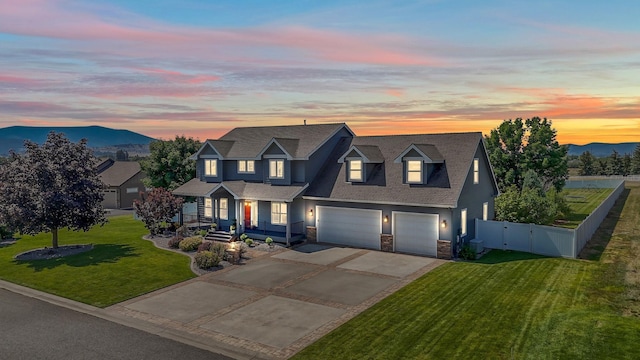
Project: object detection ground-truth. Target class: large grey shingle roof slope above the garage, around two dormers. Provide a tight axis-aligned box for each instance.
[304,132,482,208]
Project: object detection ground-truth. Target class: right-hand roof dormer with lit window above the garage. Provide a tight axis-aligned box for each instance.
[393,144,444,185]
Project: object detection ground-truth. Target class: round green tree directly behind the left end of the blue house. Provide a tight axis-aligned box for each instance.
[140,136,201,190]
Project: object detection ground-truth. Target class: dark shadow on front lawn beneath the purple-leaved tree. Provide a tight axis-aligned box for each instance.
[14,244,140,271]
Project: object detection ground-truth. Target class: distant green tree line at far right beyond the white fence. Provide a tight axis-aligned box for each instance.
[578,144,640,176]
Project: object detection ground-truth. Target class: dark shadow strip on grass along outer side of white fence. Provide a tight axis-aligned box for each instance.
[578,188,631,261]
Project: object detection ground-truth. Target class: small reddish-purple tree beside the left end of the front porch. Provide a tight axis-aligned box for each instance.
[133,188,183,235]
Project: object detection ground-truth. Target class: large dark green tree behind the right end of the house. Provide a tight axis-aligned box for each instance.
[485,117,569,192]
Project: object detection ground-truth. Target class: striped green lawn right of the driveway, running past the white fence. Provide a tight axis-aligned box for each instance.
[294,183,640,359]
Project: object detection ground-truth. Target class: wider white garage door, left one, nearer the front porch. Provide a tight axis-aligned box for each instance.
[316,206,382,250]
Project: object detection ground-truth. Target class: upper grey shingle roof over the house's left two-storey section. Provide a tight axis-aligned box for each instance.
[192,123,353,160]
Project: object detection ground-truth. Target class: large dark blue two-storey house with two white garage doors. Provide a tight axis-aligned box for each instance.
[174,124,498,258]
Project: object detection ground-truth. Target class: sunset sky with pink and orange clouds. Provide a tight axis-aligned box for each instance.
[0,0,640,144]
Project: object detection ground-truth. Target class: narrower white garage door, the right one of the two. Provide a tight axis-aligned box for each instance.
[392,211,439,256]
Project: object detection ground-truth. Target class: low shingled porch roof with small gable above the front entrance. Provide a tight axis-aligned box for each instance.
[173,179,308,202]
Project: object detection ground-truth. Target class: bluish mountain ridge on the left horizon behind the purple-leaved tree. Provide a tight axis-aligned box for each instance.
[0,126,155,154]
